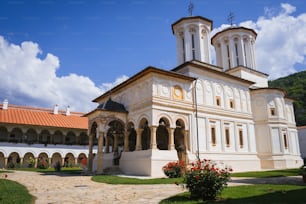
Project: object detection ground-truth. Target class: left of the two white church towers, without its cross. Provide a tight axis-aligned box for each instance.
[172,16,212,65]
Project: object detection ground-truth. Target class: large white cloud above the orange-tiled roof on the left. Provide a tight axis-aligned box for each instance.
[0,36,103,112]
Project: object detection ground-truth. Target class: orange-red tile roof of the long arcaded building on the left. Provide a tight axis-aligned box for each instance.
[0,104,88,129]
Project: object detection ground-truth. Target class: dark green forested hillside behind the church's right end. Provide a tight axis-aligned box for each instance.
[269,71,306,126]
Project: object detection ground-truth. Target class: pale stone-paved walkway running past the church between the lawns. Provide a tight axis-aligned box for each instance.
[8,171,305,204]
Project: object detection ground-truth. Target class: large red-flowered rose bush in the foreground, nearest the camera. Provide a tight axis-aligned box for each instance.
[184,159,232,200]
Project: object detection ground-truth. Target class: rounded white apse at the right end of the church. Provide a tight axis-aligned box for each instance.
[251,89,302,168]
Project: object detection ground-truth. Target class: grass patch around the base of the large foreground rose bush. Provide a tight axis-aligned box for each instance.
[160,184,306,204]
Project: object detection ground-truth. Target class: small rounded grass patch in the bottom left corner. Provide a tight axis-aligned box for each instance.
[0,179,35,204]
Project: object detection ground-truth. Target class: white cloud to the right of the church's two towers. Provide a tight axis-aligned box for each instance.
[240,4,306,79]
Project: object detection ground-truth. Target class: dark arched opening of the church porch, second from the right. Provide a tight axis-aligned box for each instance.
[156,118,170,150]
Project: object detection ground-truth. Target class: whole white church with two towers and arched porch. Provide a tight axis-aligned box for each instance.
[86,16,302,177]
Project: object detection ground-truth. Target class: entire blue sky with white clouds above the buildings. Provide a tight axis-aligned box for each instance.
[0,0,306,111]
